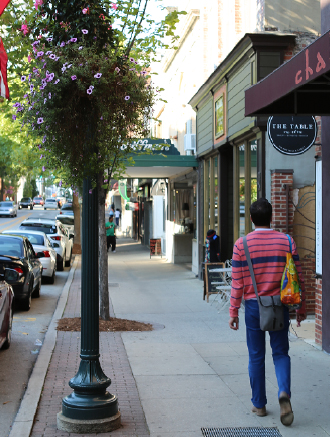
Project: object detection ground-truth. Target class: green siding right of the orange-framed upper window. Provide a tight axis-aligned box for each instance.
[228,62,251,137]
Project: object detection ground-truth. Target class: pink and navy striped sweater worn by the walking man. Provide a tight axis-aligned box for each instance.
[229,229,306,317]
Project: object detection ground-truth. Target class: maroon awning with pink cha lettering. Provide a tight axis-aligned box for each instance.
[245,32,330,116]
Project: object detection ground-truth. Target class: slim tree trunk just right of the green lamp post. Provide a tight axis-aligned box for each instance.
[97,172,110,320]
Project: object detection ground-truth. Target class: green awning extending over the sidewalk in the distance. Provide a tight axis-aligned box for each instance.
[124,154,198,179]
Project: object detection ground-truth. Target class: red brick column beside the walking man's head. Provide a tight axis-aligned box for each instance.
[271,170,293,234]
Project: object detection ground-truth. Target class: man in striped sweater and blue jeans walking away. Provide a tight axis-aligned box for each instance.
[229,199,306,426]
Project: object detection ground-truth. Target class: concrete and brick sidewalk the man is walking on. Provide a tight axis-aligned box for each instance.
[12,238,330,437]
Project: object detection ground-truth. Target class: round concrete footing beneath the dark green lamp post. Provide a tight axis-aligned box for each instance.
[57,412,121,434]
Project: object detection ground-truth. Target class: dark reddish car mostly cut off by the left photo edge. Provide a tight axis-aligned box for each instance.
[0,280,14,349]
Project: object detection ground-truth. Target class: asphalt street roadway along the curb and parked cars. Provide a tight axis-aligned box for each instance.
[0,206,69,437]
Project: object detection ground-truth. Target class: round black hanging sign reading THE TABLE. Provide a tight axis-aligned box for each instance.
[267,116,317,155]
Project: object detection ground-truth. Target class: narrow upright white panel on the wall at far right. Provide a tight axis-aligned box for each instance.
[315,160,322,275]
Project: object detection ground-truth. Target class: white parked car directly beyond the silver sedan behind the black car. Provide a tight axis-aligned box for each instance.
[19,218,73,271]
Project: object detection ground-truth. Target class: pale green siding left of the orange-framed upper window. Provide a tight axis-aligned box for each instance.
[197,98,213,155]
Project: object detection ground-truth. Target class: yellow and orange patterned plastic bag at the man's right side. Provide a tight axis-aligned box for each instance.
[281,236,302,310]
